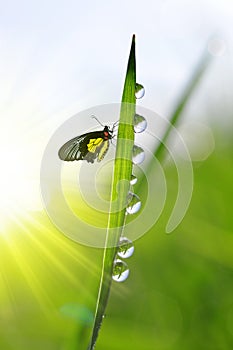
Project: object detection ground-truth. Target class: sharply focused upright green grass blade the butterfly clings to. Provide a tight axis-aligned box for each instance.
[88,36,136,350]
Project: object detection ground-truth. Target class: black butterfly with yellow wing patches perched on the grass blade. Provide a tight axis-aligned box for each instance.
[58,116,116,163]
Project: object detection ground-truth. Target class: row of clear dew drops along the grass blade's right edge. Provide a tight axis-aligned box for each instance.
[112,84,147,282]
